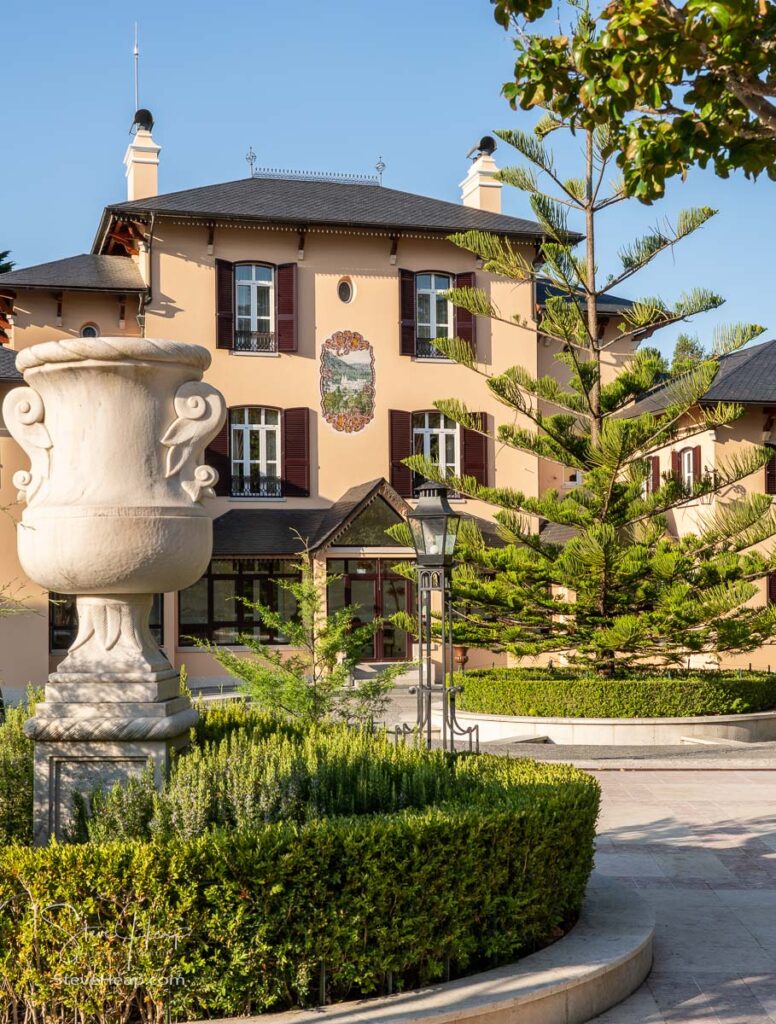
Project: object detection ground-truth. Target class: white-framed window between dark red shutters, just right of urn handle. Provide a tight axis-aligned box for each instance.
[229,407,282,498]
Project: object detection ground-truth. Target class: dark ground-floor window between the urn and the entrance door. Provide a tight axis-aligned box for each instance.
[178,558,299,647]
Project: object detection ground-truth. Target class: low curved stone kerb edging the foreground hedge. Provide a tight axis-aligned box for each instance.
[191,872,654,1024]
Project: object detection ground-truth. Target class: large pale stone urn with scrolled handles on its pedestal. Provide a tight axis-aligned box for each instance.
[3,338,226,843]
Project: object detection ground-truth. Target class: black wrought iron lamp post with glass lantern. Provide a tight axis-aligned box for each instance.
[407,482,479,752]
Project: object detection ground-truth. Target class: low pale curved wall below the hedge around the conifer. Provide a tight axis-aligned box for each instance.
[435,711,776,746]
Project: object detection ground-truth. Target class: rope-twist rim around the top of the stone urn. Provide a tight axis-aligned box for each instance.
[16,337,211,374]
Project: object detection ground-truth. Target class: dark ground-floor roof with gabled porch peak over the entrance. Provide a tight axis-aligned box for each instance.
[213,478,407,558]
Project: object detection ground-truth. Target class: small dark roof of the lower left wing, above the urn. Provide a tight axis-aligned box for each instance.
[0,253,145,292]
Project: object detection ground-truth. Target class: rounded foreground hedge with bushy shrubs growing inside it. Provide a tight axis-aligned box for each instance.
[0,712,599,1024]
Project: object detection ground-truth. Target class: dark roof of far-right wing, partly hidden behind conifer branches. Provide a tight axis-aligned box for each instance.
[619,339,776,417]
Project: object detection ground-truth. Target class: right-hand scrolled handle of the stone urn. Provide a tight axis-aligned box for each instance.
[162,381,226,502]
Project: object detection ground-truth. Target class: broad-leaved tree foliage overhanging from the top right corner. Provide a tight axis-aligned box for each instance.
[494,0,776,201]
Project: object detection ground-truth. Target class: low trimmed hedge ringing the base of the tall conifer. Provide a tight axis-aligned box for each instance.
[456,669,776,718]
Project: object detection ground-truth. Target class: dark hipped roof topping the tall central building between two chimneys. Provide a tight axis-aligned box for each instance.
[106,178,543,239]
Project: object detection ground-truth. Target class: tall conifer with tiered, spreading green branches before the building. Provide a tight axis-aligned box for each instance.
[407,116,776,673]
